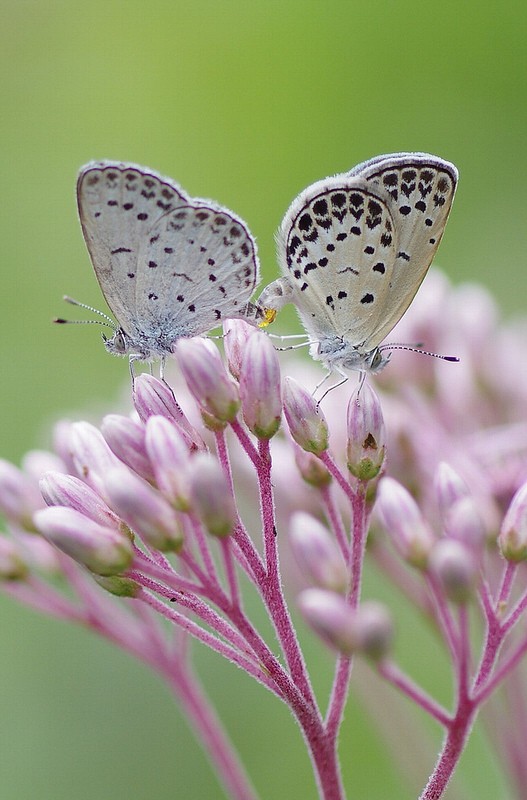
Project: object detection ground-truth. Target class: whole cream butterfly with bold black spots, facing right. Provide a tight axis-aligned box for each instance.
[258,153,458,378]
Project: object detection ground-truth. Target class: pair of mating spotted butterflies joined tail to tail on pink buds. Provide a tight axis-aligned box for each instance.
[62,153,458,376]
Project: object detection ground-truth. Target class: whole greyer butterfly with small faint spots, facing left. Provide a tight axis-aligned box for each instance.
[56,161,259,376]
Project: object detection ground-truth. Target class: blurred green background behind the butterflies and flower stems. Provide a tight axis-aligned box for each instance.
[0,0,527,800]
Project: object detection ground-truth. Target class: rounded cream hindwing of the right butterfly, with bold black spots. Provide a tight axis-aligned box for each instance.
[278,175,399,347]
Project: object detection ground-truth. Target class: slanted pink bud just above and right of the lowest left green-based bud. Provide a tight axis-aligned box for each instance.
[105,467,183,552]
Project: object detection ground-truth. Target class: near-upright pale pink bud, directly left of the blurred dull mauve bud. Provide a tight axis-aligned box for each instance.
[145,416,191,511]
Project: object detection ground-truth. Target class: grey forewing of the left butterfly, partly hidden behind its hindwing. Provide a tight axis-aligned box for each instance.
[77,161,188,339]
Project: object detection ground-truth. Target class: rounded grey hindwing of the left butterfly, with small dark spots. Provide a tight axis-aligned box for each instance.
[135,200,259,342]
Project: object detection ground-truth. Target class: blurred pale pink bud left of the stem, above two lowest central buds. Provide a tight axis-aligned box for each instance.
[289,511,348,592]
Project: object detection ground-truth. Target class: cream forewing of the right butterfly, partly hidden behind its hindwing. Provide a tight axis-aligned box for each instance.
[347,153,458,349]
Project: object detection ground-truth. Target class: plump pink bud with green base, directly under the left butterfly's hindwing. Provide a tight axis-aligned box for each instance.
[176,338,240,429]
